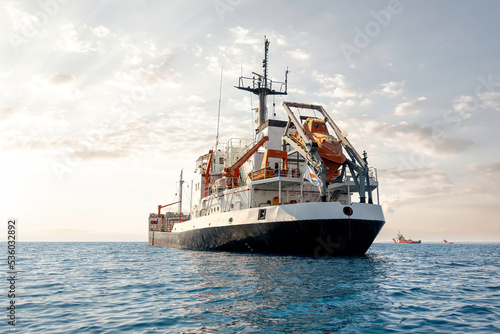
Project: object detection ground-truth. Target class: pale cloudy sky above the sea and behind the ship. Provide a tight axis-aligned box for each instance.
[0,0,500,242]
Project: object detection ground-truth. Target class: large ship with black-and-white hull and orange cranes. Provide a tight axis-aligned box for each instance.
[148,39,385,257]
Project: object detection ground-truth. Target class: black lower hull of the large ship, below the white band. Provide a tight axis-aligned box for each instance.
[149,218,385,257]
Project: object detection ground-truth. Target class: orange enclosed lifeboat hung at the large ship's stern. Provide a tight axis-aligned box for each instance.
[291,117,346,180]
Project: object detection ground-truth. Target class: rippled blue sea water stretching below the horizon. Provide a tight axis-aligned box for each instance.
[0,243,500,333]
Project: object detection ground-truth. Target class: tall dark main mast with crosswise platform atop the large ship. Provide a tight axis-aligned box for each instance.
[235,36,288,128]
